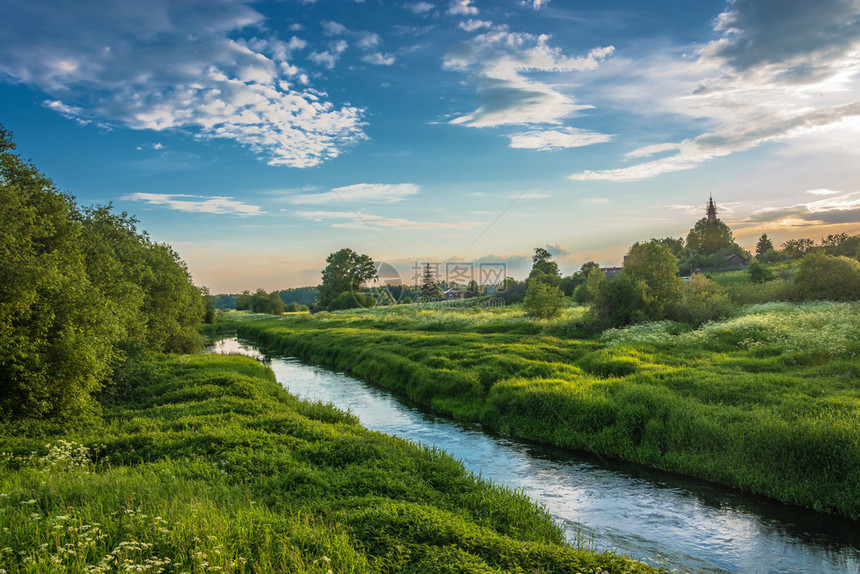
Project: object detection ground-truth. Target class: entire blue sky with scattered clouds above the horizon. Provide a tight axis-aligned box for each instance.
[0,0,860,292]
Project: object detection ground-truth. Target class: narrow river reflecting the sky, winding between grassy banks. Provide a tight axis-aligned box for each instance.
[212,339,860,574]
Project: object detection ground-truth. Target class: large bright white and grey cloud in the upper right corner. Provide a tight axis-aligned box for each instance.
[571,0,860,181]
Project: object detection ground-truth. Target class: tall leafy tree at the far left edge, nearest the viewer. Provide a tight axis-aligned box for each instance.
[0,126,116,416]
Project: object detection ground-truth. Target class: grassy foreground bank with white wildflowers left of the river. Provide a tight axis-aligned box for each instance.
[0,355,653,574]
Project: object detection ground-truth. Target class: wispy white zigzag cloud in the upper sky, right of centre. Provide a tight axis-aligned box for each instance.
[443,26,614,127]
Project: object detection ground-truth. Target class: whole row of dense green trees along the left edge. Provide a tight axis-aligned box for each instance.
[0,126,206,416]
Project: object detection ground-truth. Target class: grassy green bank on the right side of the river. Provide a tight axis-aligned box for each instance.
[238,303,860,520]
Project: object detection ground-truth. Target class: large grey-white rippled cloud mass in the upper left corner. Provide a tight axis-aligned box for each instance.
[0,0,365,167]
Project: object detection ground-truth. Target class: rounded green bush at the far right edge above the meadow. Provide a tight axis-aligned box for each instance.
[795,252,860,301]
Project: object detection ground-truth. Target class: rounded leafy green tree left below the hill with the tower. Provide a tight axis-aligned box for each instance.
[623,241,682,319]
